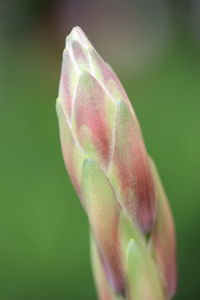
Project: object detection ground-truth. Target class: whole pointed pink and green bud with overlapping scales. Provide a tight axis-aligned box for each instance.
[56,27,176,300]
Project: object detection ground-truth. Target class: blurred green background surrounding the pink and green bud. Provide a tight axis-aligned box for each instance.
[0,0,200,300]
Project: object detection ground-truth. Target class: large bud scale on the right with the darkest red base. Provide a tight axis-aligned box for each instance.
[108,101,156,233]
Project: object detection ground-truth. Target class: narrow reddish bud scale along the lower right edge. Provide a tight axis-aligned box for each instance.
[150,162,177,298]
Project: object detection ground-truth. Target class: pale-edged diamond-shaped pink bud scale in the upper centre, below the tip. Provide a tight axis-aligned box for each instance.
[73,71,114,167]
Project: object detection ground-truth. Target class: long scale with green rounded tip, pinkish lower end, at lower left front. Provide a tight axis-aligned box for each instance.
[82,159,125,294]
